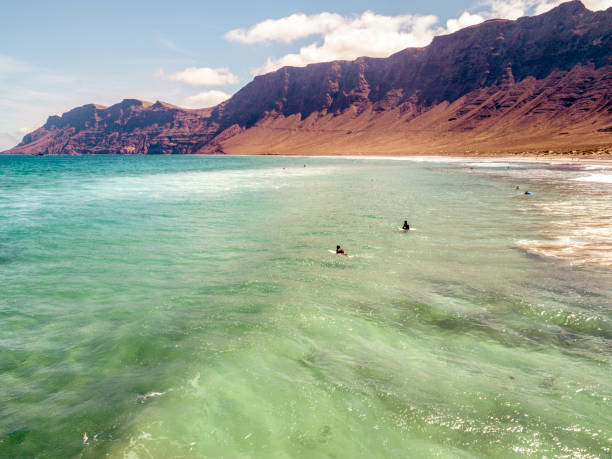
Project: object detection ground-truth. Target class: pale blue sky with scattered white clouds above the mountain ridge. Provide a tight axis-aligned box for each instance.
[0,0,612,151]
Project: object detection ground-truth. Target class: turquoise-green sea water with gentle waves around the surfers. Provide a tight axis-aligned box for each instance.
[0,157,612,458]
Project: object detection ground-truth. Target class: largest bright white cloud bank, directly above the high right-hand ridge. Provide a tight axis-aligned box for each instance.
[234,0,612,75]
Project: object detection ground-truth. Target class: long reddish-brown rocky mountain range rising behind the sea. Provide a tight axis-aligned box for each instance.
[7,1,612,154]
